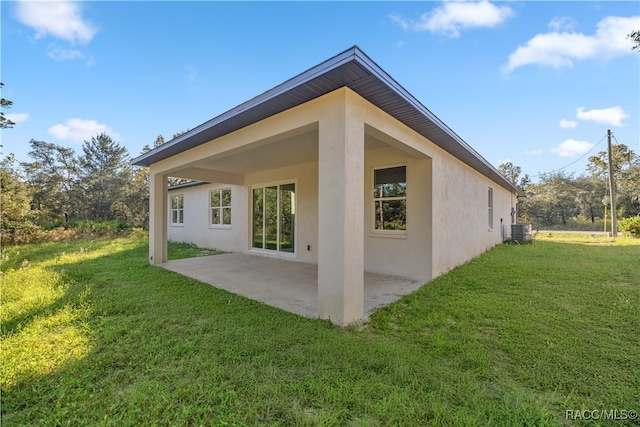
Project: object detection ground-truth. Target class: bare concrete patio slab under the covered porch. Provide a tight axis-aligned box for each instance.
[161,253,423,320]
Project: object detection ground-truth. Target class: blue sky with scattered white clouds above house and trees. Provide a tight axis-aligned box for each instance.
[0,0,640,176]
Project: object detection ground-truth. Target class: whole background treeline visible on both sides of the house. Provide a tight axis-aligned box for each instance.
[0,133,640,242]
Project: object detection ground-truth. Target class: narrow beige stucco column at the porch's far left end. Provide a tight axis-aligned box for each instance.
[149,173,168,264]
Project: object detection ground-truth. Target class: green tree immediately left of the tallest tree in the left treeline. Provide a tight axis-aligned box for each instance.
[22,139,79,222]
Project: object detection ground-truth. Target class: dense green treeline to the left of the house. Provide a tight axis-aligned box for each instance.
[0,133,159,242]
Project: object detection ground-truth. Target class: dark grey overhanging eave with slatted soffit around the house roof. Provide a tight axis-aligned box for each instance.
[131,46,520,194]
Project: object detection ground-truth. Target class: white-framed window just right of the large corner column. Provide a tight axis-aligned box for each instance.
[373,166,407,231]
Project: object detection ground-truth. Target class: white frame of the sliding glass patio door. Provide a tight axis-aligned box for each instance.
[248,179,299,258]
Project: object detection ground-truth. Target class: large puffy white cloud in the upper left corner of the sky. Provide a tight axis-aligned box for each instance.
[16,0,97,43]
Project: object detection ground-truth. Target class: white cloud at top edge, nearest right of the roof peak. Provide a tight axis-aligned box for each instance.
[390,0,514,38]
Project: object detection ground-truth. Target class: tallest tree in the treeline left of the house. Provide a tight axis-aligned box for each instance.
[79,133,131,220]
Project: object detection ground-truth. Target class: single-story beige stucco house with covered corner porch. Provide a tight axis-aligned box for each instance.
[132,46,519,325]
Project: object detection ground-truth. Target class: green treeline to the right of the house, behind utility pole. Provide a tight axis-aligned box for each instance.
[498,144,640,231]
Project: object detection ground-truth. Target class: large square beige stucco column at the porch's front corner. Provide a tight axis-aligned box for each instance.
[318,98,364,325]
